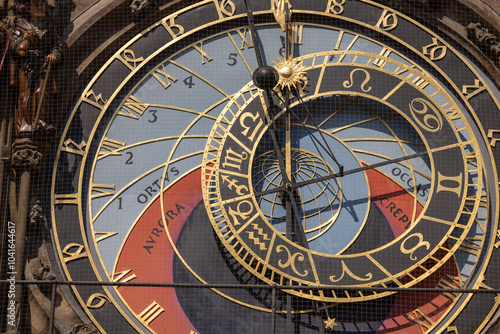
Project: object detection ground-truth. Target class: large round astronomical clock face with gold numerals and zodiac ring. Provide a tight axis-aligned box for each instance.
[51,0,500,333]
